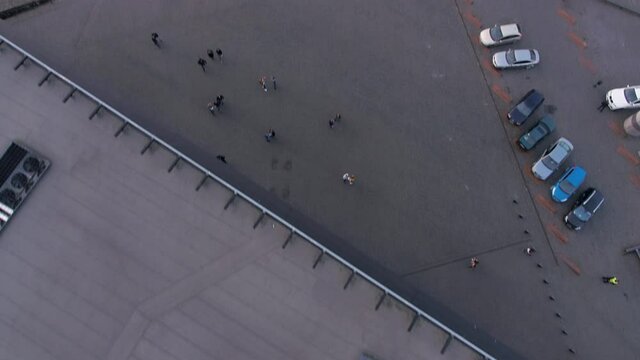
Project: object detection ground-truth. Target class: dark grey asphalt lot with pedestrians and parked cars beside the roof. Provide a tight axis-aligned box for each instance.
[0,0,640,358]
